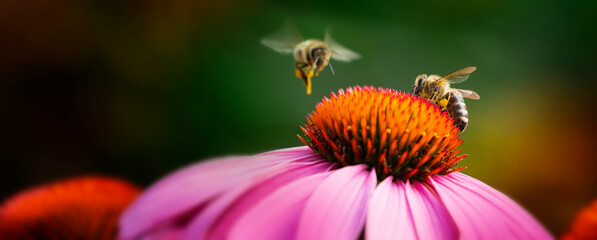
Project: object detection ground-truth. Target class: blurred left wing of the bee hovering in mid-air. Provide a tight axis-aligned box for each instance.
[261,21,303,53]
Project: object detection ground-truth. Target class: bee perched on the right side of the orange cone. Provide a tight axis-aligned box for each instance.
[413,67,480,132]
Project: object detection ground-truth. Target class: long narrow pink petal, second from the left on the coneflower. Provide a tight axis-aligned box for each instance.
[184,157,332,239]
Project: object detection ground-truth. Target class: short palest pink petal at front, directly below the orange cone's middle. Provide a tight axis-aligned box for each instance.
[365,177,417,240]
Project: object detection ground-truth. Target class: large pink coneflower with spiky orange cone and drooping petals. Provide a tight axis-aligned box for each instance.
[119,87,552,240]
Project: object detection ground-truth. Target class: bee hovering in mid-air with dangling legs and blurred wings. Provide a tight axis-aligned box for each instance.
[261,22,361,94]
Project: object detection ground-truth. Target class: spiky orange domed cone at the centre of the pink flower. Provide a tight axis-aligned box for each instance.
[299,86,466,181]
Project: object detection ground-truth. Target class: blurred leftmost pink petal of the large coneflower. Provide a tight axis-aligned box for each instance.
[119,148,322,239]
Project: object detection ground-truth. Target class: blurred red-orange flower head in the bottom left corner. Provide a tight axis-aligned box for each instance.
[0,176,140,239]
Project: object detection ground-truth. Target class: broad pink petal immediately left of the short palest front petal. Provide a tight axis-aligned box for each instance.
[297,165,377,239]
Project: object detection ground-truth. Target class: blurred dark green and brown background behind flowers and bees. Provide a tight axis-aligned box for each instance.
[0,0,597,235]
